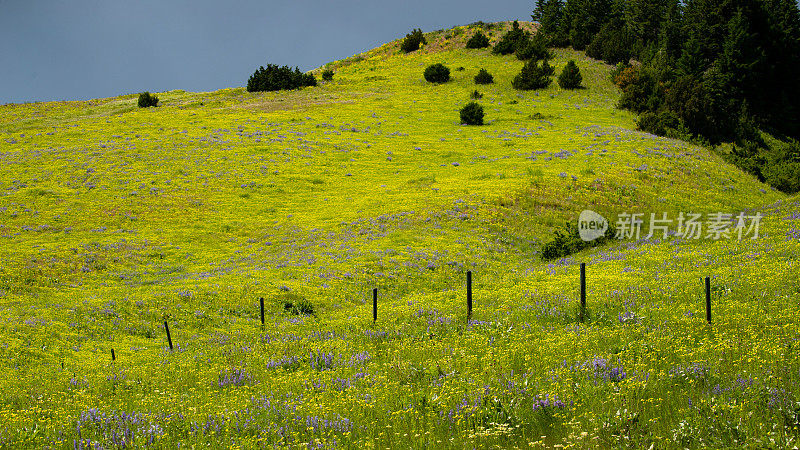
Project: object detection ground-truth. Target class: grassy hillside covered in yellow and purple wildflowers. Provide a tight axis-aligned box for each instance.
[0,24,800,448]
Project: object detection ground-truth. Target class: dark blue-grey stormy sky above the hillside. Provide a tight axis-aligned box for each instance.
[0,0,533,104]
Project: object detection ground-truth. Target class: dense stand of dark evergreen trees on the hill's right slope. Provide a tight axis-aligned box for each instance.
[532,0,800,192]
